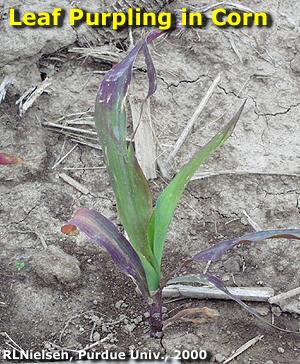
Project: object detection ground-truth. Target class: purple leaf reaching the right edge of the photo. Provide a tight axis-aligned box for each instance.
[193,229,300,262]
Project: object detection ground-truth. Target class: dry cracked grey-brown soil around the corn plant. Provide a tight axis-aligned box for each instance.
[0,0,300,364]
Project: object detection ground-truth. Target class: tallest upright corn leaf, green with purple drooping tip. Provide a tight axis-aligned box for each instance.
[95,31,162,262]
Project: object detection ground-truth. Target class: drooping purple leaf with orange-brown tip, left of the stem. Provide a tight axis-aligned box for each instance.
[61,208,149,298]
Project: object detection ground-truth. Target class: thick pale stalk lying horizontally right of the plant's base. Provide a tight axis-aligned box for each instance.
[163,284,274,302]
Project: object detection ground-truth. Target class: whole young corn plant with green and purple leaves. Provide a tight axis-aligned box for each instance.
[62,31,300,337]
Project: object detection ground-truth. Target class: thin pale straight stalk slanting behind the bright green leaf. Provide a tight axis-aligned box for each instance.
[166,73,221,173]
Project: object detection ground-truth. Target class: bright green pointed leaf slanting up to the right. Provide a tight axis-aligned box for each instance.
[148,101,246,269]
